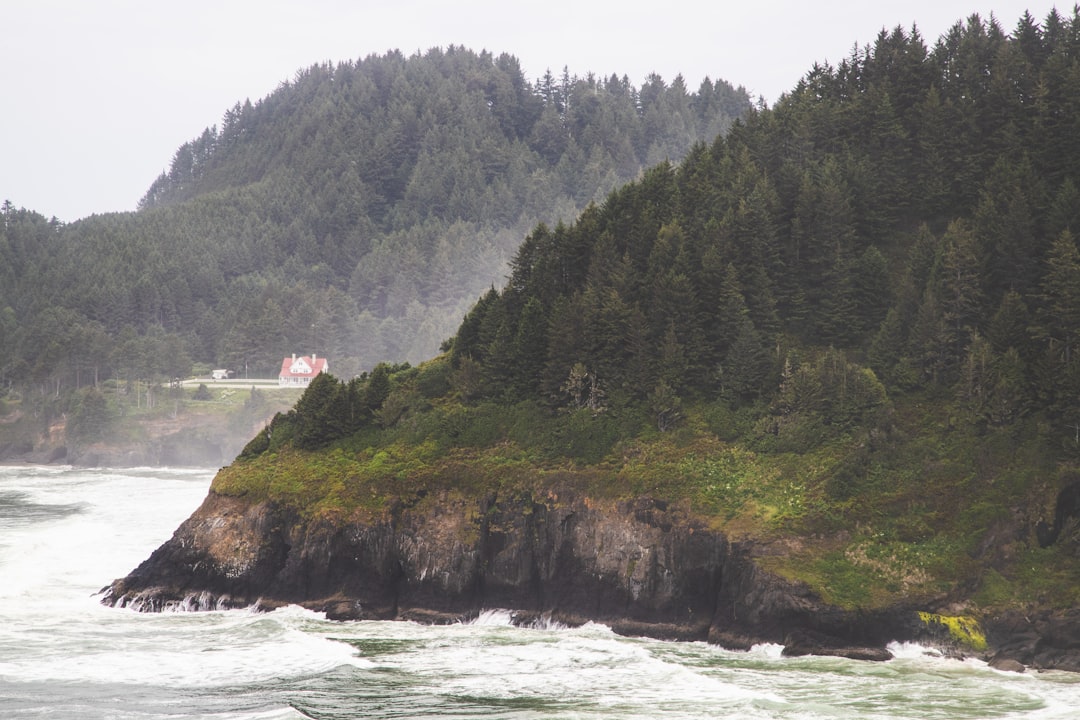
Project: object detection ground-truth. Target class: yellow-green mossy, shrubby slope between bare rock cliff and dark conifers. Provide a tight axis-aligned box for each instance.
[213,357,1080,615]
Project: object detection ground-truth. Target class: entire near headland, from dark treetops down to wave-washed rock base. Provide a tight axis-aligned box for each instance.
[110,8,1080,669]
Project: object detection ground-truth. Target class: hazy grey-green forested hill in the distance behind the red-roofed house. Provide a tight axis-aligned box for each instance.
[0,46,751,405]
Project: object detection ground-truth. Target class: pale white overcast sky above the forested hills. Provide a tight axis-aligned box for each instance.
[0,0,1058,221]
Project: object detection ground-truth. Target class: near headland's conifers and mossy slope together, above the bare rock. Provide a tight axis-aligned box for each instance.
[221,12,1080,609]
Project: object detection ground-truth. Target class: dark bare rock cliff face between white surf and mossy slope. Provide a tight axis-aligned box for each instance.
[103,492,1080,669]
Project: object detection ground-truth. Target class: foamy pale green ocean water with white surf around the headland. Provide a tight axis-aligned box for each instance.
[0,466,1080,720]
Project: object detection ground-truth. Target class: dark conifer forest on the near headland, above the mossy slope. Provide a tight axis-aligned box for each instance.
[434,8,1080,427]
